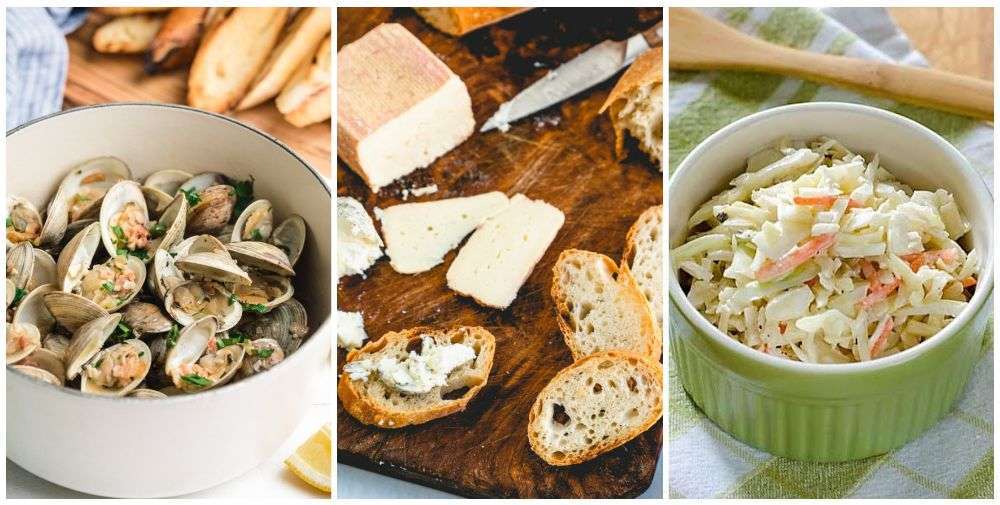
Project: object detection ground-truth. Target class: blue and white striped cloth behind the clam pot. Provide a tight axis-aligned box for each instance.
[7,7,87,130]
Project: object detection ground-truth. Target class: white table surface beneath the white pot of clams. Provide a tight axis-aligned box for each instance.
[7,361,333,499]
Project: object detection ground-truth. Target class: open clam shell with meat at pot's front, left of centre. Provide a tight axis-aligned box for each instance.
[80,338,152,396]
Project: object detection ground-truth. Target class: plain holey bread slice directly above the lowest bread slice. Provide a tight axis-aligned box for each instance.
[552,249,661,361]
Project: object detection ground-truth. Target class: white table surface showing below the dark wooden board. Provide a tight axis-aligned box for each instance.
[336,452,663,498]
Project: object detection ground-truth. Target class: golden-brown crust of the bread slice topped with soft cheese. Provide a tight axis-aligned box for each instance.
[337,326,496,429]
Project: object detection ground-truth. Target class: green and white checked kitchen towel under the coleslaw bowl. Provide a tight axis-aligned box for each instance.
[669,8,993,498]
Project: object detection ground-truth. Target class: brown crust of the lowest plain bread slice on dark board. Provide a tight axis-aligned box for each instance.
[528,351,663,466]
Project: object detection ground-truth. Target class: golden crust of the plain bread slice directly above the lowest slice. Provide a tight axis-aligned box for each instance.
[552,249,663,361]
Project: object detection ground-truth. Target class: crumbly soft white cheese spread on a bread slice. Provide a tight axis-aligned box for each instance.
[344,336,476,394]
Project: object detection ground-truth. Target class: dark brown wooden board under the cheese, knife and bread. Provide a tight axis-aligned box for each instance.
[337,8,663,498]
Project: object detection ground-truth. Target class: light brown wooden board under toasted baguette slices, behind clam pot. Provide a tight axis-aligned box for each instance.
[63,14,331,176]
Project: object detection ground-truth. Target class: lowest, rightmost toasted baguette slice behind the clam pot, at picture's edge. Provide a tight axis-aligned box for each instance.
[274,35,332,128]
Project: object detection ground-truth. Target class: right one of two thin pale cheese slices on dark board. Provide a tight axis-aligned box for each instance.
[447,194,565,309]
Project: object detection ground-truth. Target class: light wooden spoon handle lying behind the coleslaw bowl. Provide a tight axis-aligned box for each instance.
[668,8,993,121]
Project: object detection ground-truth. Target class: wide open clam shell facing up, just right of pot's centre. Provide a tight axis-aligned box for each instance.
[165,280,243,331]
